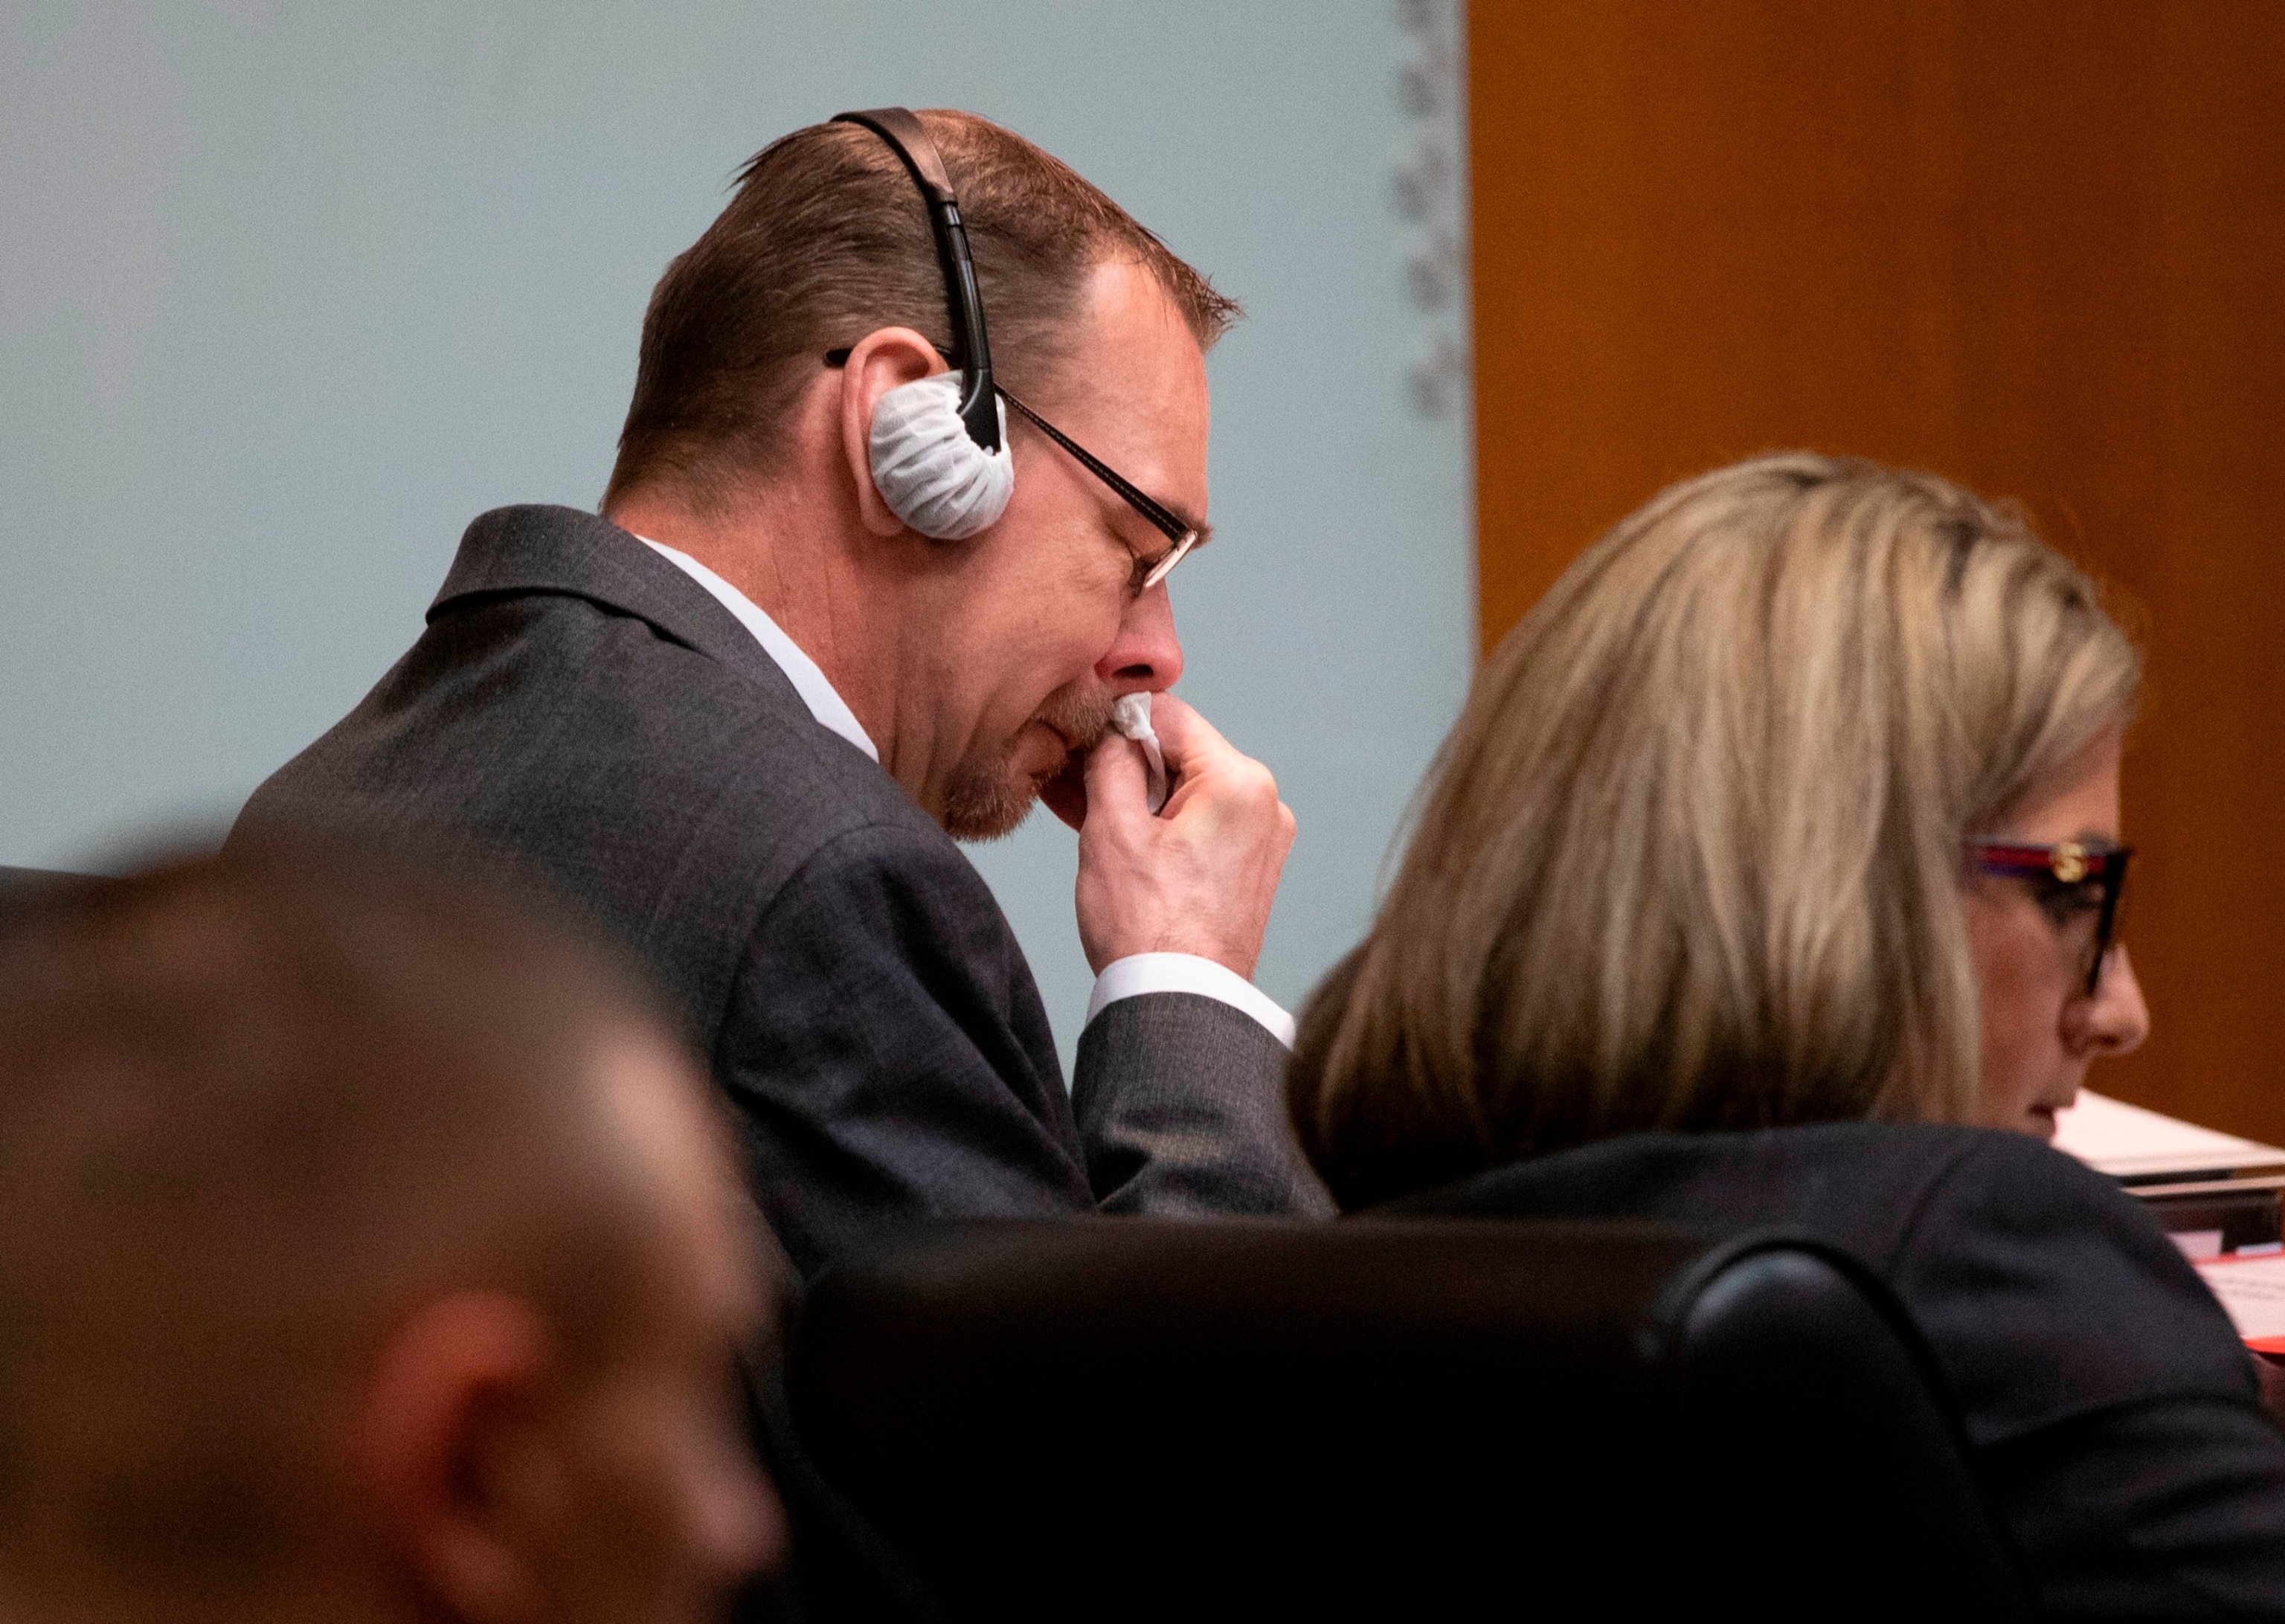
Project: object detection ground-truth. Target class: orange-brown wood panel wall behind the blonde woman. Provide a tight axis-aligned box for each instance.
[1469,0,2285,1142]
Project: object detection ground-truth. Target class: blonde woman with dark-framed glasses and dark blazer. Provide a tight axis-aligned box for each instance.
[1291,454,2285,1615]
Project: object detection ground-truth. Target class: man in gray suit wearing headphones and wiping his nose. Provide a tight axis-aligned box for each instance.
[240,109,1330,1277]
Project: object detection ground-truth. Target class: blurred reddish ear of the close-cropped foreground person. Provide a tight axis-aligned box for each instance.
[356,1291,562,1624]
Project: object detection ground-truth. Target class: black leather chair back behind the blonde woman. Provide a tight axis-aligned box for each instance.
[772,1219,2022,1622]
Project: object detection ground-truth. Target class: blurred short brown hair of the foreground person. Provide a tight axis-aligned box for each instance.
[0,845,699,1590]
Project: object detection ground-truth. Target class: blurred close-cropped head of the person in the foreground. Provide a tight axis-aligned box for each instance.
[0,848,782,1622]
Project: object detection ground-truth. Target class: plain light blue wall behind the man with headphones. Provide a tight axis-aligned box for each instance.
[0,0,1473,1046]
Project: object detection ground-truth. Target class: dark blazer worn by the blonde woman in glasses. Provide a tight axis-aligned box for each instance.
[1392,1121,2285,1620]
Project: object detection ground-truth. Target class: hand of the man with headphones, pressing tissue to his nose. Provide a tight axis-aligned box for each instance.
[1055,695,1293,978]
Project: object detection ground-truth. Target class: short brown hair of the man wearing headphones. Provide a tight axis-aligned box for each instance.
[603,109,1238,509]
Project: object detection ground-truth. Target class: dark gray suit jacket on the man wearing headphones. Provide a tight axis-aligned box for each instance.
[233,507,1330,1277]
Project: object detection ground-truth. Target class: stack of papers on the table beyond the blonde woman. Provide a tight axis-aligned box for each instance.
[2054,1089,2285,1355]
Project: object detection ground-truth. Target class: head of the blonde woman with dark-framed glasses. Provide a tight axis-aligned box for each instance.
[1291,452,2148,1206]
